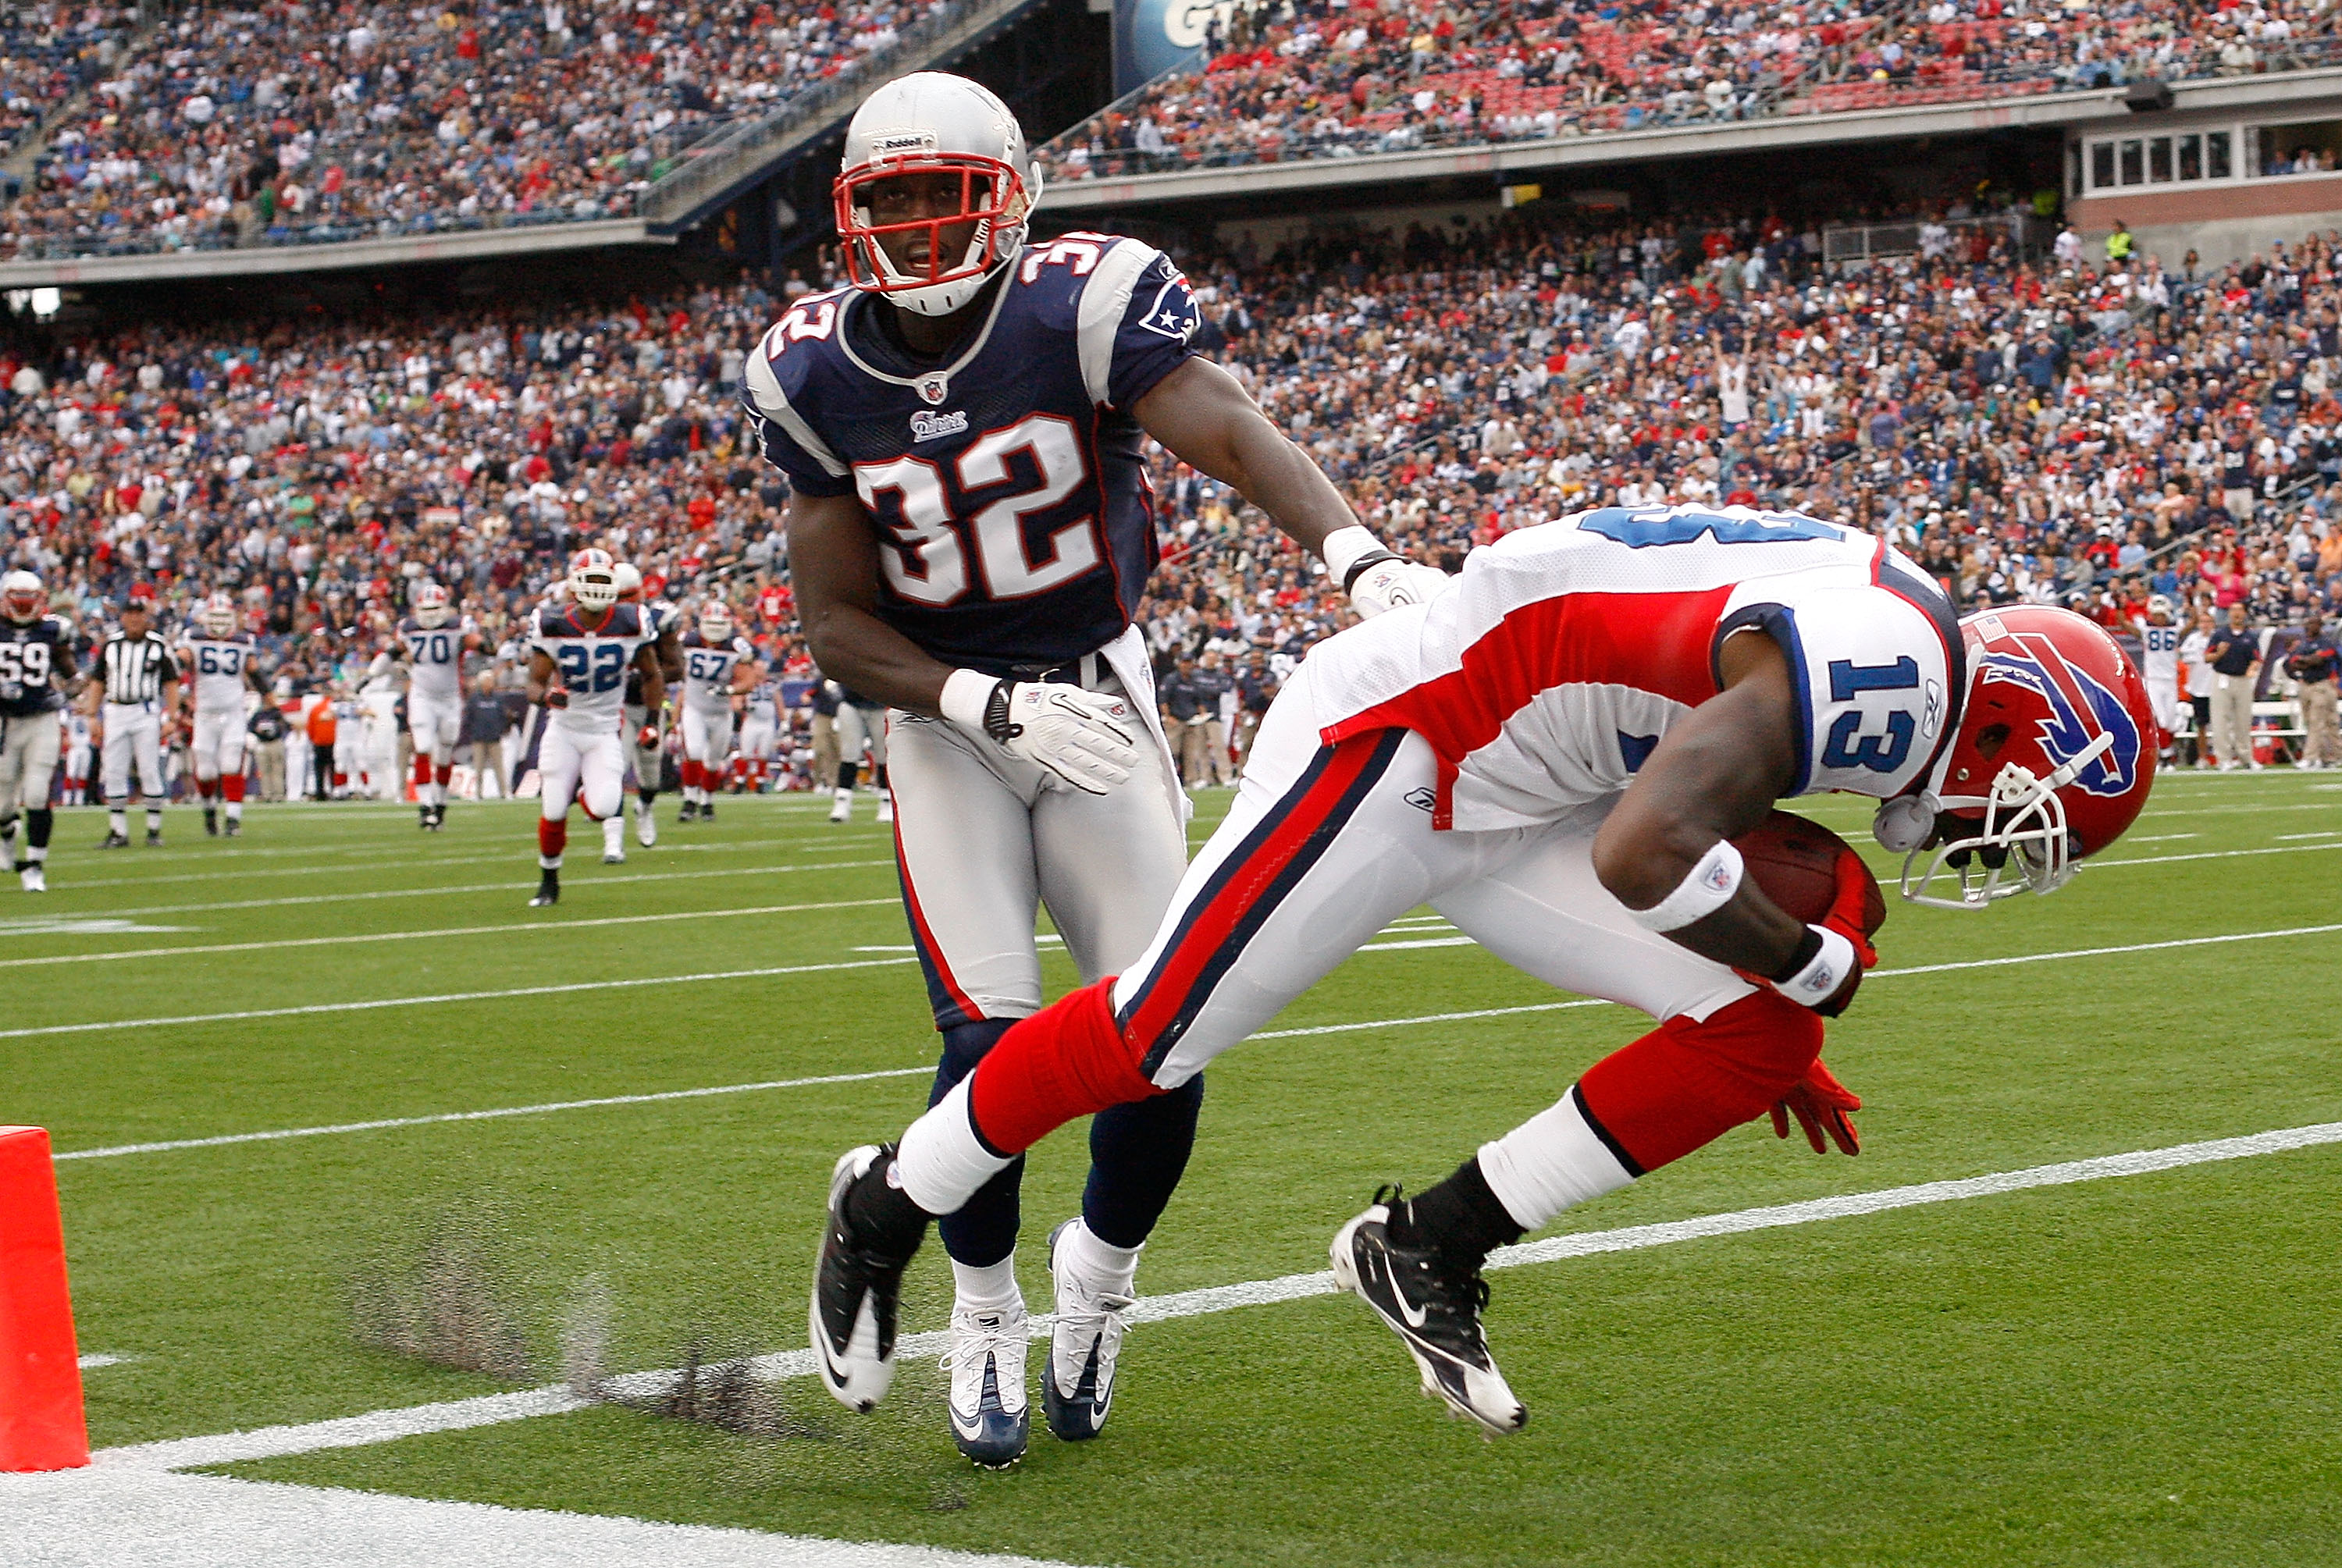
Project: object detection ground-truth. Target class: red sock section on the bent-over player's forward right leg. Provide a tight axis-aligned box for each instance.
[1574,990,1822,1170]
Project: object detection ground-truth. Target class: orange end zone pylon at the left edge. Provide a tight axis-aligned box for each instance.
[0,1128,89,1470]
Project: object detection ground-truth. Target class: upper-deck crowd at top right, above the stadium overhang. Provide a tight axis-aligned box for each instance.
[1045,0,2333,180]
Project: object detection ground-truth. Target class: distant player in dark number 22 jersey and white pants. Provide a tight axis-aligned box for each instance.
[529,550,667,908]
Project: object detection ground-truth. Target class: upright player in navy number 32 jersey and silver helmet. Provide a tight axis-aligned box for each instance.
[747,73,1440,1465]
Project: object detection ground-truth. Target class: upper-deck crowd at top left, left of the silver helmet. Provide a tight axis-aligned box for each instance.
[0,0,951,260]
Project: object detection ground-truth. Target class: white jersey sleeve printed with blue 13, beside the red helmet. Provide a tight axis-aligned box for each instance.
[1740,588,1951,800]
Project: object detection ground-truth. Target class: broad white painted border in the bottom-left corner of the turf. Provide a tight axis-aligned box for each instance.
[0,1465,1087,1568]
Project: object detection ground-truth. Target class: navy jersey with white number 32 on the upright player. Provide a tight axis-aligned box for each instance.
[747,234,1199,674]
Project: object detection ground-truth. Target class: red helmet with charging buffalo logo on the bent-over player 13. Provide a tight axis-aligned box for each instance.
[1874,604,2155,908]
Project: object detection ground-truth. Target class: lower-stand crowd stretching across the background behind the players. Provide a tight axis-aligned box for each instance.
[0,196,2342,805]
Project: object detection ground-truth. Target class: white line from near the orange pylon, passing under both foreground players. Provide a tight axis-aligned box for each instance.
[96,1121,2342,1470]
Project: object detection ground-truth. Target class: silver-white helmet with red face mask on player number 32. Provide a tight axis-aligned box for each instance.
[829,70,1040,316]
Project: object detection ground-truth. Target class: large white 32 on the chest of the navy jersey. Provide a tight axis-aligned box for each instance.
[855,414,1098,606]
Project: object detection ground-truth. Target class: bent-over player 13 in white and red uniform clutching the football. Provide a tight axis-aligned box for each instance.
[815,508,2155,1435]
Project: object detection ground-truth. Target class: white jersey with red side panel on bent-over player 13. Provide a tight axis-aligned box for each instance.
[1307,506,1965,830]
